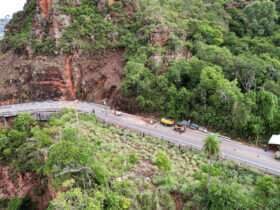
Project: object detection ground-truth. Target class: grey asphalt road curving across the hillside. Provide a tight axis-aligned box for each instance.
[0,101,280,176]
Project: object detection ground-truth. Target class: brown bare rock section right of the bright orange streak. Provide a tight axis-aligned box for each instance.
[73,50,124,104]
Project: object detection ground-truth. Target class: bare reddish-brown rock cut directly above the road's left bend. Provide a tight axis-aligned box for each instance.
[0,50,124,105]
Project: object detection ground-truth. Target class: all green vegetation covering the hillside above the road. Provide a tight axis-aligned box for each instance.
[0,0,280,143]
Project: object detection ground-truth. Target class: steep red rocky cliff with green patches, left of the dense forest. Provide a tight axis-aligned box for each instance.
[0,0,191,108]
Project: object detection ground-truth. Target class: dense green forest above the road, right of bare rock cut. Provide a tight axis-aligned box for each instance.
[123,1,280,143]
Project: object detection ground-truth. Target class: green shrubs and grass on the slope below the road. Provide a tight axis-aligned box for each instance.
[0,110,280,210]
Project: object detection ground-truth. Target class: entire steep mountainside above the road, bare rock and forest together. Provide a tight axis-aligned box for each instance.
[0,0,280,143]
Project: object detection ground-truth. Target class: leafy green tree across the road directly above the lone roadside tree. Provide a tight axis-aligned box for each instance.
[195,67,241,129]
